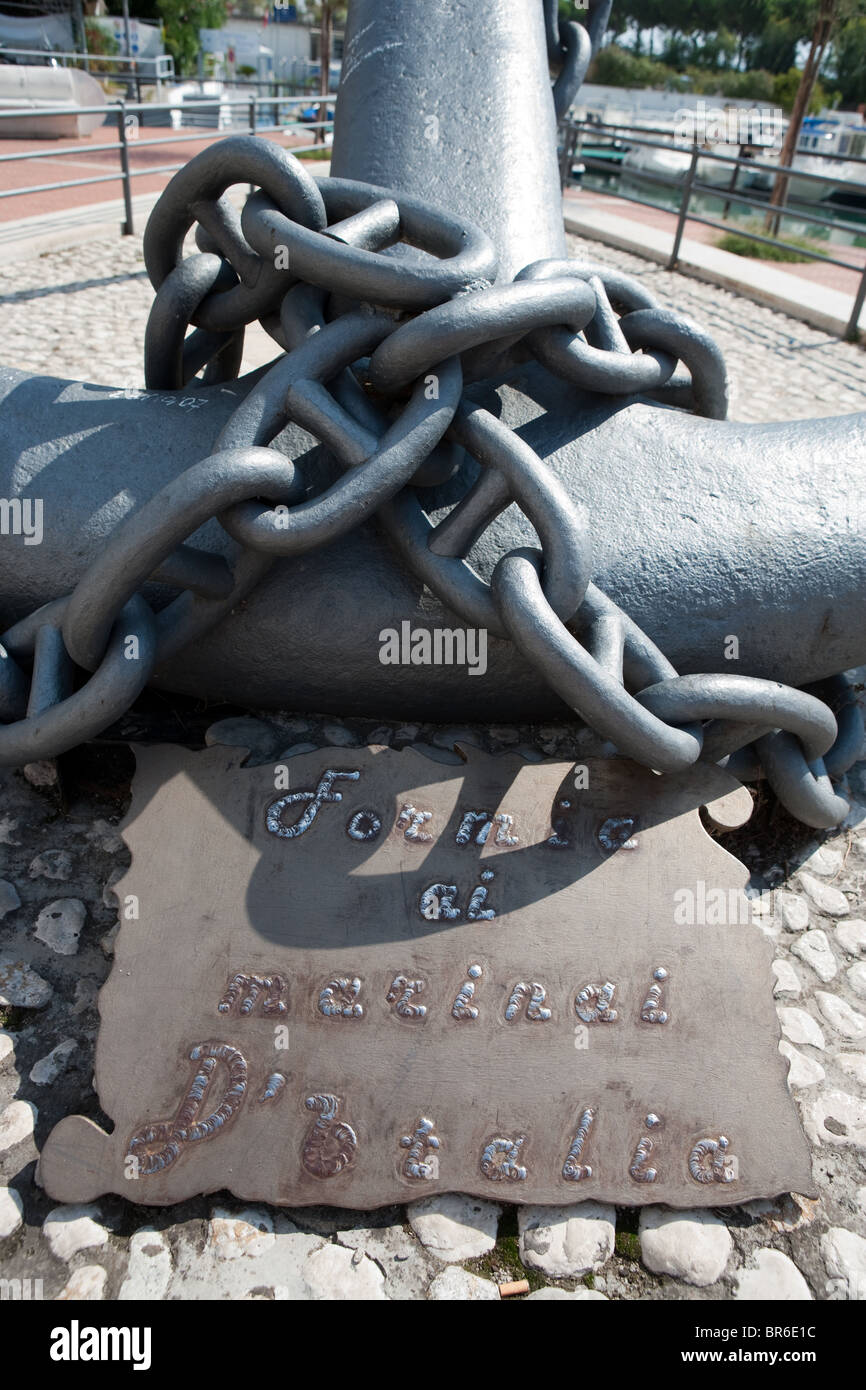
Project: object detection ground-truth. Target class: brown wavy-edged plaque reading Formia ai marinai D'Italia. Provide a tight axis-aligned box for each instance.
[40,748,812,1208]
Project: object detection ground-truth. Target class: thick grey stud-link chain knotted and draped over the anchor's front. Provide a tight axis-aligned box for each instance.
[0,127,863,826]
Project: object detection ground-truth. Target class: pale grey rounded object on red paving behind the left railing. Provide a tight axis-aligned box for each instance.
[0,63,106,140]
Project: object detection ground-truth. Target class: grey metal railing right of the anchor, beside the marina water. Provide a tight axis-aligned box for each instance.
[560,121,866,341]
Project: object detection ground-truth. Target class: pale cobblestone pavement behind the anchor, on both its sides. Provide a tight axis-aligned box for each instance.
[0,236,866,421]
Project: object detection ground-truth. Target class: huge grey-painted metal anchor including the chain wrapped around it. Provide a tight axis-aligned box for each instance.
[0,0,866,826]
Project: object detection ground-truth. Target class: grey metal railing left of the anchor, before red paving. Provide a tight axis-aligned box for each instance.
[0,93,334,236]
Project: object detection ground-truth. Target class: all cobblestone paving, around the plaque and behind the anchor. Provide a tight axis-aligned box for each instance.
[0,230,866,1301]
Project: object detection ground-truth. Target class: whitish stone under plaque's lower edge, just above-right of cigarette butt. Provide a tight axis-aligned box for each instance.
[517,1201,616,1279]
